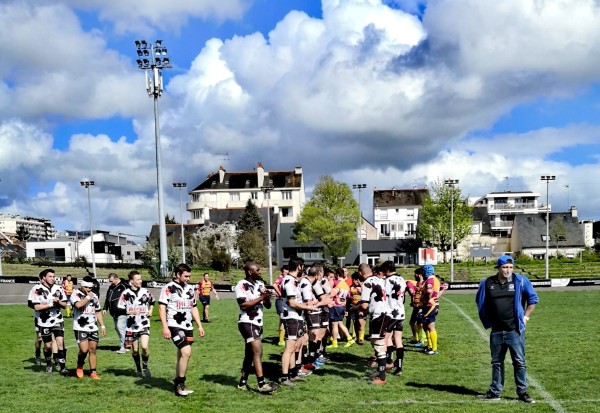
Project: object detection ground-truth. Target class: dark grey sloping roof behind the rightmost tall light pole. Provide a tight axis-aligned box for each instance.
[513,212,585,248]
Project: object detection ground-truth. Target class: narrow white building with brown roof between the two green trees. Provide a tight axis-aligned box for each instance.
[373,188,429,239]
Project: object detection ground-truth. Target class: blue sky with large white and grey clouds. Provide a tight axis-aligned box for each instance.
[0,0,600,240]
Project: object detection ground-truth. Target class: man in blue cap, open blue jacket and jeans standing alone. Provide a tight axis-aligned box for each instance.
[475,255,539,403]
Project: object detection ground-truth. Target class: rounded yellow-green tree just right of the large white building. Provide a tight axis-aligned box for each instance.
[293,176,360,260]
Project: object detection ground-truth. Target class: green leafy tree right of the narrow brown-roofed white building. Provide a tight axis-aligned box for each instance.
[417,179,473,261]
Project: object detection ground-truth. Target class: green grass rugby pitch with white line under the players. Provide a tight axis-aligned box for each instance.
[0,290,600,413]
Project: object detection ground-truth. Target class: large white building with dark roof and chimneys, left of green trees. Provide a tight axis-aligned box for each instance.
[186,163,305,225]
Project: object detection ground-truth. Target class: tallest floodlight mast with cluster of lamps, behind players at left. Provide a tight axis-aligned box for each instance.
[135,40,172,278]
